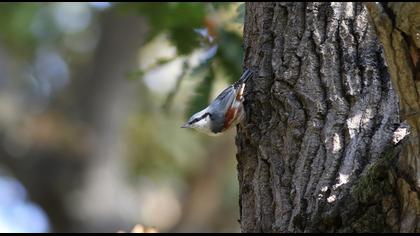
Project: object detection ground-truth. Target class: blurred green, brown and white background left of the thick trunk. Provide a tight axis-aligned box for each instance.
[0,2,244,232]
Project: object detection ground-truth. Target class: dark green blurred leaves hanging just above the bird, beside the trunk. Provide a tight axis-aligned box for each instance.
[120,2,244,118]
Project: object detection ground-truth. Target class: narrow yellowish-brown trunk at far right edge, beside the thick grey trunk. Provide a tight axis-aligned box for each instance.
[366,2,420,232]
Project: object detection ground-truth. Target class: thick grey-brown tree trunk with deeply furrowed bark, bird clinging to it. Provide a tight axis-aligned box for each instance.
[236,3,420,232]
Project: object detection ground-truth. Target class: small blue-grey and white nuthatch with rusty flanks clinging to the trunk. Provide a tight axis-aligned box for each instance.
[181,69,253,136]
